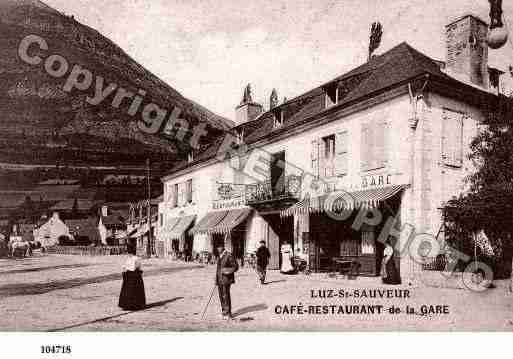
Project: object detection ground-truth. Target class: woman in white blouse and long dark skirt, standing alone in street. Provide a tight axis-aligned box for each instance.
[118,243,146,310]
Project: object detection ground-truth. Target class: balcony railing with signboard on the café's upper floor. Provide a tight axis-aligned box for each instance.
[217,175,301,204]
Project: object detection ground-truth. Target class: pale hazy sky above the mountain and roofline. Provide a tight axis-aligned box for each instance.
[43,0,513,119]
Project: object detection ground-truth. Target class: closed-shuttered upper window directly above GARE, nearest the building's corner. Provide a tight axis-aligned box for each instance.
[360,118,388,171]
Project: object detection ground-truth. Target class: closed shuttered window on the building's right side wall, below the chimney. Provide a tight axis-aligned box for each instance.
[442,109,464,167]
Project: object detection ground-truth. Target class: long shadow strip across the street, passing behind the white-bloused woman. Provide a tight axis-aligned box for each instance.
[0,265,203,298]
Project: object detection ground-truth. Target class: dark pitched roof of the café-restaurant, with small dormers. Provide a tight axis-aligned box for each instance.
[169,42,498,179]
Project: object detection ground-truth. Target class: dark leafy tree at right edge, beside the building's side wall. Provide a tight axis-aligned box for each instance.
[444,96,513,277]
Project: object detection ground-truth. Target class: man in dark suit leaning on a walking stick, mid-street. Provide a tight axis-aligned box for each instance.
[216,243,239,319]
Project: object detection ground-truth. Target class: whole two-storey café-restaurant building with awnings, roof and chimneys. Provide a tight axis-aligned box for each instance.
[157,16,500,282]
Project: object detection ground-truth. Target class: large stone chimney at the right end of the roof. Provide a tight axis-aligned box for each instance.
[445,15,489,89]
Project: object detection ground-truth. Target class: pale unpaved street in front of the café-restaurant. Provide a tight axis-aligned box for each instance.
[0,255,513,331]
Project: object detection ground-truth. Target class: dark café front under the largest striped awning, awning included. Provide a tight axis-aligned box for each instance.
[282,185,407,276]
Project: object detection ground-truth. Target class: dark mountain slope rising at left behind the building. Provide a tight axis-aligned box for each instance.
[0,0,231,166]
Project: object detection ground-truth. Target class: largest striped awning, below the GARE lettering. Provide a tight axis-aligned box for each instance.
[281,185,409,217]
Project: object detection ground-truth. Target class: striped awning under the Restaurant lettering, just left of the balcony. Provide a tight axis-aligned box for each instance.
[190,208,251,234]
